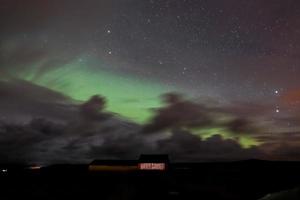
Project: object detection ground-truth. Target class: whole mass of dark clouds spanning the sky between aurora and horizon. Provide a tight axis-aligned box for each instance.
[0,80,298,164]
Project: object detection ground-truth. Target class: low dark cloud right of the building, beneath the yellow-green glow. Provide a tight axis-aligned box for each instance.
[158,130,263,161]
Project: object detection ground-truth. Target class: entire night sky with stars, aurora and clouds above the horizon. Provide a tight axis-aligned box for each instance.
[0,0,300,163]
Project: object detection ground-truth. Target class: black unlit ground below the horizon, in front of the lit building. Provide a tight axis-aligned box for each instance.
[0,160,300,200]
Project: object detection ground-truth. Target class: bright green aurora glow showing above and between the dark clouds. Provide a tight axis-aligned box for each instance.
[5,57,260,148]
